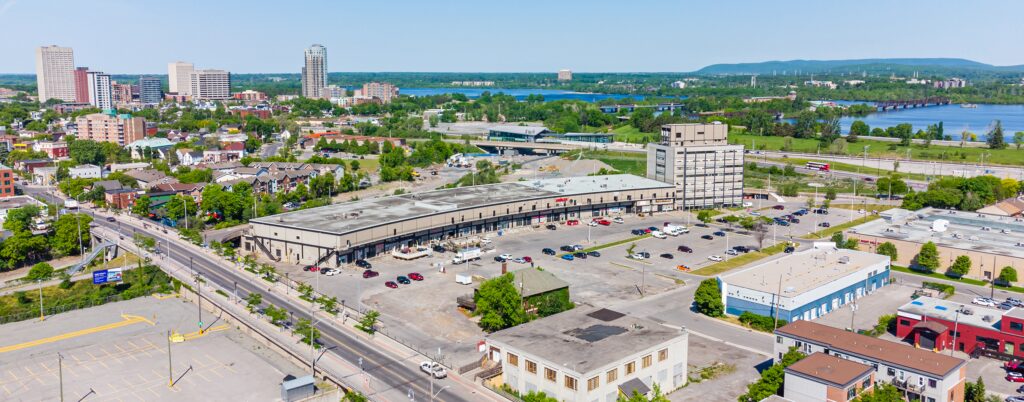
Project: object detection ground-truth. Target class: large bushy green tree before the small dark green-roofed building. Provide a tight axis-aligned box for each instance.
[474,273,527,332]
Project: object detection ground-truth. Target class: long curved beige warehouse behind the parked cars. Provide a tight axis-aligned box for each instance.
[242,175,675,266]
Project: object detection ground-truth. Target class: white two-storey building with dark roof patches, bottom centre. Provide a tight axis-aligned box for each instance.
[486,306,689,402]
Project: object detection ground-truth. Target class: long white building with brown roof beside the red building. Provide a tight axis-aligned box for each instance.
[774,320,967,402]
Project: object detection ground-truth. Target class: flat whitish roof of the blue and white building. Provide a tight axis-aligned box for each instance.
[722,242,889,298]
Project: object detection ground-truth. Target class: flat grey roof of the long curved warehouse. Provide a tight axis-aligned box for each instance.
[250,175,673,234]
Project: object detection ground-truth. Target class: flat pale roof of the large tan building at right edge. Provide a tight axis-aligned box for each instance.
[850,208,1024,258]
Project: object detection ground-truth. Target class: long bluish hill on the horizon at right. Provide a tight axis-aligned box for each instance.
[694,58,1024,75]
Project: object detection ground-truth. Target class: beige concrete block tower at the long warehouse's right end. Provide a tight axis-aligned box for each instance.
[647,124,743,209]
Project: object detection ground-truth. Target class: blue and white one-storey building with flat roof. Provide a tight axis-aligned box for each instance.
[718,242,890,322]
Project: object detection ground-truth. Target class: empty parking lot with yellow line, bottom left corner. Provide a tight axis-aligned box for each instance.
[0,292,303,401]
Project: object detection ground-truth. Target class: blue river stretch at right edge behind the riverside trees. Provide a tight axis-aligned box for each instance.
[836,100,1024,140]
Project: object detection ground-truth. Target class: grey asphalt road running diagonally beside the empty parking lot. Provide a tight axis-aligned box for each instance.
[93,212,481,402]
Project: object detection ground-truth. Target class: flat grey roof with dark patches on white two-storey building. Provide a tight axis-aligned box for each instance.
[487,306,686,374]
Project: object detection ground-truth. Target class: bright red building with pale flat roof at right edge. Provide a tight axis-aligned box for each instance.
[896,297,1024,360]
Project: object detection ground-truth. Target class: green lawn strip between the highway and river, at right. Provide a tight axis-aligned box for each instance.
[729,133,1024,166]
